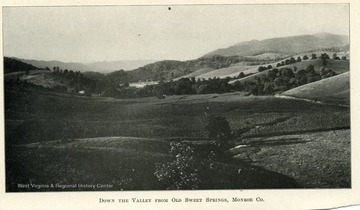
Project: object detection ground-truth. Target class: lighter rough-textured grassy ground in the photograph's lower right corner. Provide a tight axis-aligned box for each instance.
[229,130,351,188]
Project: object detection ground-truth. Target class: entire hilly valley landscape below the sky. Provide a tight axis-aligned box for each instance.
[4,33,351,192]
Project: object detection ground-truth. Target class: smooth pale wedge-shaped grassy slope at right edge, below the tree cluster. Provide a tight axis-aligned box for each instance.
[282,72,350,105]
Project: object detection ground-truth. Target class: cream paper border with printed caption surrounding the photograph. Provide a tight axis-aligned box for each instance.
[0,0,360,210]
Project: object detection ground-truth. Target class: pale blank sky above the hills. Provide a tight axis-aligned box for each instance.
[3,4,349,63]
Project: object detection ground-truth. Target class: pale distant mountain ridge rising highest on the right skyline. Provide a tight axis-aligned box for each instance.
[203,33,349,57]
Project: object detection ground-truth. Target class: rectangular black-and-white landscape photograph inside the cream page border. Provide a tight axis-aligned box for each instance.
[2,3,352,194]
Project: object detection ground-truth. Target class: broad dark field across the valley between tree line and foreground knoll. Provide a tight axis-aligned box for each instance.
[5,91,350,144]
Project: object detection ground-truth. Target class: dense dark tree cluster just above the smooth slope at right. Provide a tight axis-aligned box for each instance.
[243,65,336,95]
